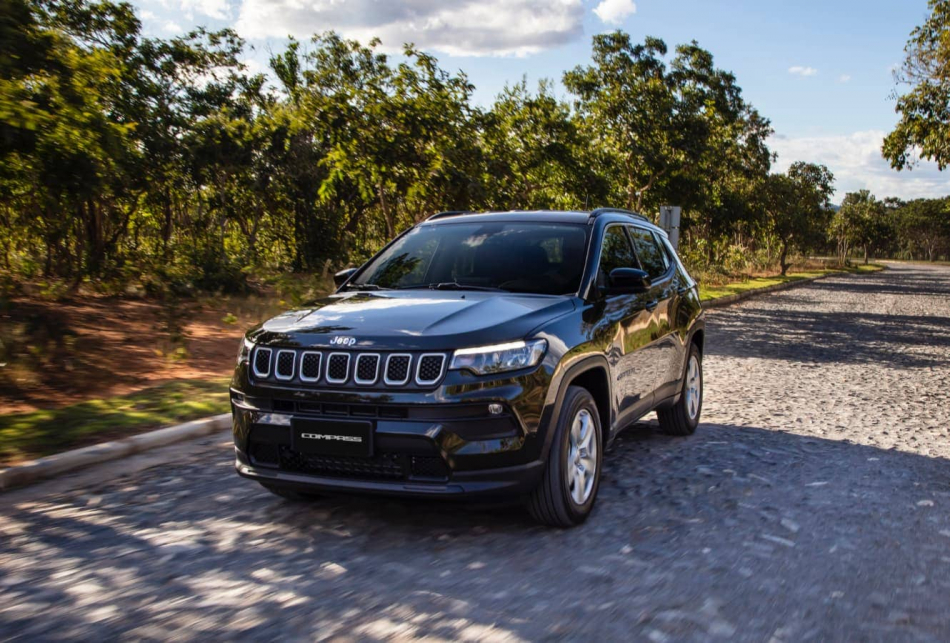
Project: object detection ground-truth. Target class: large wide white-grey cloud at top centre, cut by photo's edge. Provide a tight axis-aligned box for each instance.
[234,0,584,56]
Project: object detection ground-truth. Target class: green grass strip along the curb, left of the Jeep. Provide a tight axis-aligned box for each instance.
[0,380,229,463]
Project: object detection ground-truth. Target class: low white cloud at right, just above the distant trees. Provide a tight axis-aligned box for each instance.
[769,130,950,202]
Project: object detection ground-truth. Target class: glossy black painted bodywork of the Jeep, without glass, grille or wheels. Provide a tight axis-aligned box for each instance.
[231,212,705,497]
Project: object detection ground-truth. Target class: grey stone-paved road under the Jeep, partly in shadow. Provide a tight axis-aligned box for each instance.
[0,264,950,641]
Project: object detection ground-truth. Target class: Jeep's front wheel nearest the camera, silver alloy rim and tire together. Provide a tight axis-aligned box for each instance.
[528,386,603,527]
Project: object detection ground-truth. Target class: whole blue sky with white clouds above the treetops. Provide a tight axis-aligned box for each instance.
[133,0,950,200]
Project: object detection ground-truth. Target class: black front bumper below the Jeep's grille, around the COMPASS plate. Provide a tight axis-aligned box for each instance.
[231,368,548,498]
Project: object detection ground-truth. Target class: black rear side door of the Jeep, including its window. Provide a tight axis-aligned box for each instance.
[629,225,682,402]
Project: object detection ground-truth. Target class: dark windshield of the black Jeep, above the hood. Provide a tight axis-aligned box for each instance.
[349,221,588,295]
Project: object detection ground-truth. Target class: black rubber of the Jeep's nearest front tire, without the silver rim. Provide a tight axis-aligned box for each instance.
[527,386,604,527]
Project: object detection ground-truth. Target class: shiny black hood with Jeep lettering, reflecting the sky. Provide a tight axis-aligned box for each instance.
[248,290,575,350]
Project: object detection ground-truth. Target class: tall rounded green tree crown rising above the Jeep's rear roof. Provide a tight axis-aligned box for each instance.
[564,31,767,216]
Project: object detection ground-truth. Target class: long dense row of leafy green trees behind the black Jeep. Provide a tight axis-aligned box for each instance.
[11,0,940,291]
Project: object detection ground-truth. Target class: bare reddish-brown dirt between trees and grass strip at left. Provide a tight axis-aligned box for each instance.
[0,296,280,415]
